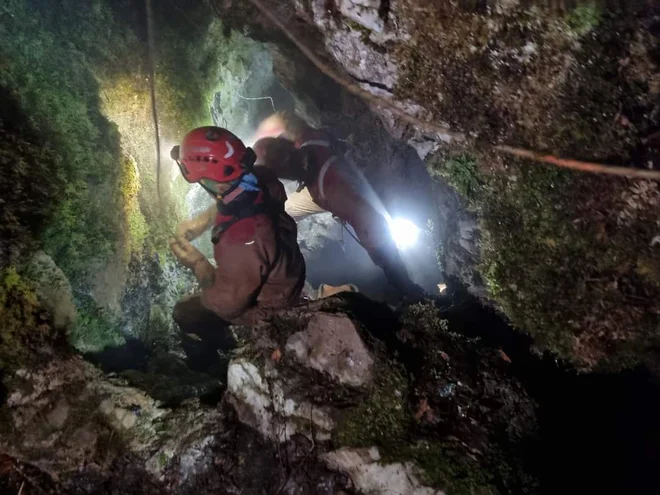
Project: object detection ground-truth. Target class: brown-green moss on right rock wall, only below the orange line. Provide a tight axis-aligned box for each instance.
[430,151,660,368]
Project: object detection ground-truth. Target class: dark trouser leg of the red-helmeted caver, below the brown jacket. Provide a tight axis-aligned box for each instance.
[173,294,236,372]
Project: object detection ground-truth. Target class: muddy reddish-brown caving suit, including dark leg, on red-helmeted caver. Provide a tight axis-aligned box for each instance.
[174,170,305,370]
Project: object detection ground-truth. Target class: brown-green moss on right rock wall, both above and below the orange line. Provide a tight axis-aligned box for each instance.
[396,2,660,368]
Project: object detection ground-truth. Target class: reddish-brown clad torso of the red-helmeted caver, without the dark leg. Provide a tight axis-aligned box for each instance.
[202,165,305,324]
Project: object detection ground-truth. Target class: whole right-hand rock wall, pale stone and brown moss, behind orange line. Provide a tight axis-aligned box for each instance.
[227,0,660,369]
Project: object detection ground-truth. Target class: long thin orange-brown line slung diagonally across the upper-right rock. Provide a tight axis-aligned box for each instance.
[241,0,660,180]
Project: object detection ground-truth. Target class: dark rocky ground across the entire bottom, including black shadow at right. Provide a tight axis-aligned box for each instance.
[0,294,660,495]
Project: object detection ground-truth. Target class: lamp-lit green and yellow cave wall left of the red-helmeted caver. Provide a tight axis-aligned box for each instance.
[0,0,276,364]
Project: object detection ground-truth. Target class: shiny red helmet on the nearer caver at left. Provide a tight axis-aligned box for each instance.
[172,127,255,182]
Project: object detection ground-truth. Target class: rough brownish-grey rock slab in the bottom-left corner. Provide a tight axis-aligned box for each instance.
[0,358,222,481]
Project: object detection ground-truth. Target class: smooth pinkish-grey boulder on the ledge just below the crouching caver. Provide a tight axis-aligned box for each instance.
[286,313,374,387]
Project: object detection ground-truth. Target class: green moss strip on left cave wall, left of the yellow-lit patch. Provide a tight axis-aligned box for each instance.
[0,0,130,279]
